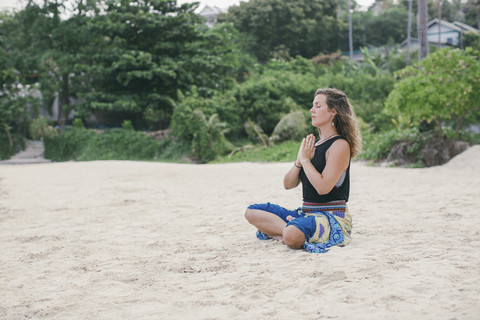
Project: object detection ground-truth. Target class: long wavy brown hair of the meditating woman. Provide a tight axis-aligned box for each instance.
[314,88,362,158]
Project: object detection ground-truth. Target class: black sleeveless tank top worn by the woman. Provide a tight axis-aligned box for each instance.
[300,136,350,203]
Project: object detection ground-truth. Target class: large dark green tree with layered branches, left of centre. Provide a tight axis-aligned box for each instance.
[76,0,246,129]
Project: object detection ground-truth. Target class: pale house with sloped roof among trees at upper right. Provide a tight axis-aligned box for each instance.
[427,18,479,47]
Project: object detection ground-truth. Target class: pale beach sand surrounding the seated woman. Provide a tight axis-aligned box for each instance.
[0,146,480,319]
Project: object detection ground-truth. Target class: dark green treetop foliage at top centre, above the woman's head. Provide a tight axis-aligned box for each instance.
[219,0,340,62]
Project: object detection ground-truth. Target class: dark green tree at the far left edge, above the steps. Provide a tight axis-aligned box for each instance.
[2,0,97,132]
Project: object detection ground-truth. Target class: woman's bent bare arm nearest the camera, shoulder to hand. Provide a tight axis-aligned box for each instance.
[300,139,350,195]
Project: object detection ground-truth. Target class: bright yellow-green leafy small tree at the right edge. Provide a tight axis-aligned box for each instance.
[386,48,480,136]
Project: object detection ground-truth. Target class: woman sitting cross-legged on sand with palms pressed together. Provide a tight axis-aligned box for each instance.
[245,88,361,252]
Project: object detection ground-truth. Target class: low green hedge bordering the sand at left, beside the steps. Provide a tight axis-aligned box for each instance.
[44,128,163,161]
